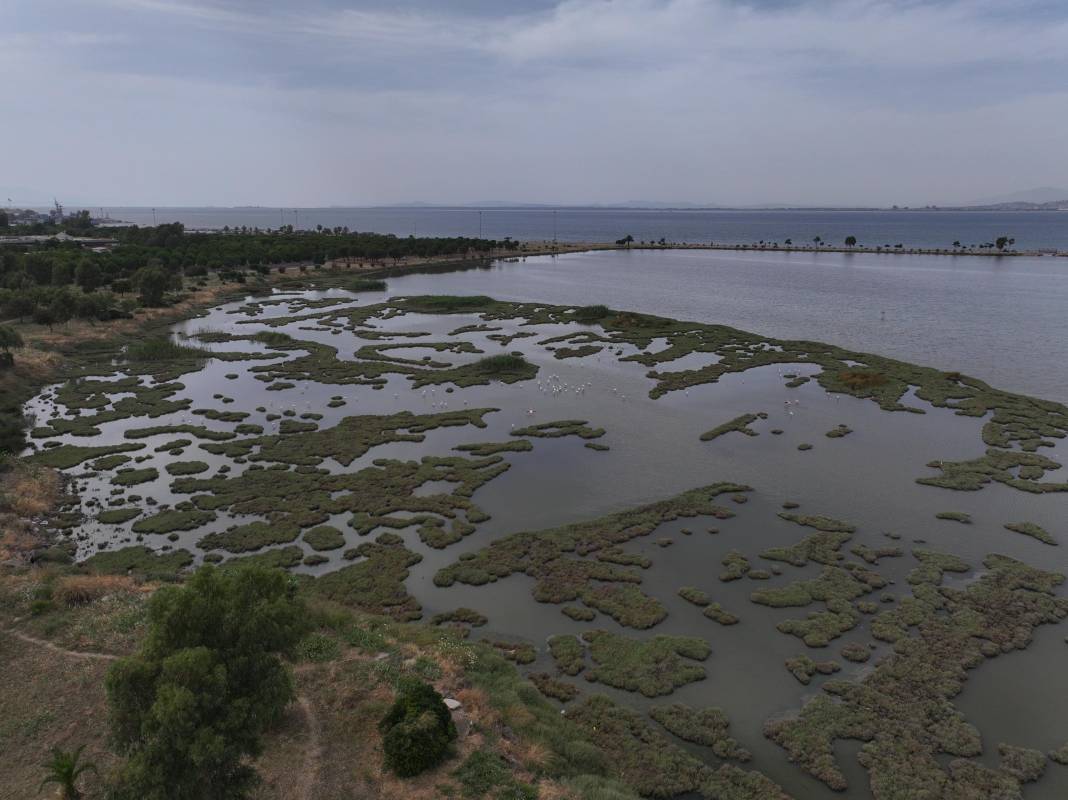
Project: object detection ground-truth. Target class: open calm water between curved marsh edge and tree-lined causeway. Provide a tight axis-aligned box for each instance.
[389,250,1068,402]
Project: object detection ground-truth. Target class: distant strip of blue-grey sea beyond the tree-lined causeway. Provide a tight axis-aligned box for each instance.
[106,207,1068,250]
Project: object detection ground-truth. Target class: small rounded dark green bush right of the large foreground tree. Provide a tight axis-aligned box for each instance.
[378,678,456,778]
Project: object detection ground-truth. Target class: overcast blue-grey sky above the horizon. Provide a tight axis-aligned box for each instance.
[0,0,1068,206]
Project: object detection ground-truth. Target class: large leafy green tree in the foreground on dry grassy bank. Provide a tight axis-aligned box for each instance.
[106,566,305,800]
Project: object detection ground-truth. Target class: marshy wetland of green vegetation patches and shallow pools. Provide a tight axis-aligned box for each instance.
[16,253,1068,800]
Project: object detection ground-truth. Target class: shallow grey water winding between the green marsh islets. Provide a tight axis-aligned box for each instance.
[22,273,1068,799]
